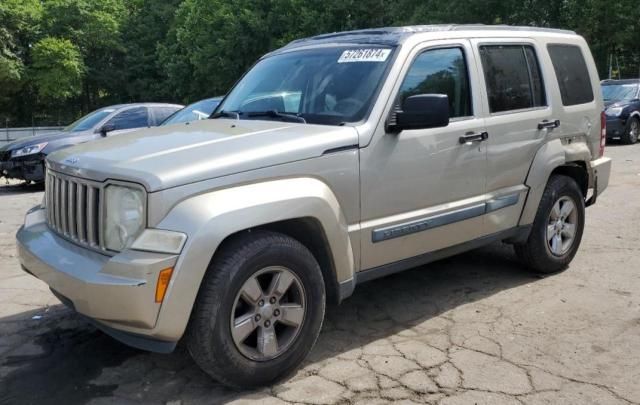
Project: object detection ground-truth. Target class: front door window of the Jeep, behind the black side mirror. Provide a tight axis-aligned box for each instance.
[398,48,473,118]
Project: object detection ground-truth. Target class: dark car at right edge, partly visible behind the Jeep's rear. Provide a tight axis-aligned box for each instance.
[602,79,640,144]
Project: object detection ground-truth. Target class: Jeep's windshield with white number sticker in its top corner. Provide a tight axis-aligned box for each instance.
[216,46,392,125]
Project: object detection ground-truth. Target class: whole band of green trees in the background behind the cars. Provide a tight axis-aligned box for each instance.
[0,0,640,125]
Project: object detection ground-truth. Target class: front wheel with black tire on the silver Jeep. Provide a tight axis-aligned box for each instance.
[186,231,326,388]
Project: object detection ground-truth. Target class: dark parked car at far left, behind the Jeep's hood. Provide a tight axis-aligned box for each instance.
[0,103,183,182]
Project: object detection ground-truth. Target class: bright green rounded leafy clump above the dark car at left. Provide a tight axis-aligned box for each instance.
[31,37,85,101]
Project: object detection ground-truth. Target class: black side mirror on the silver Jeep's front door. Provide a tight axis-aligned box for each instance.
[393,94,449,132]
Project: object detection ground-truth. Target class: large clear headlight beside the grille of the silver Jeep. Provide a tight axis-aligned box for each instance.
[104,184,144,251]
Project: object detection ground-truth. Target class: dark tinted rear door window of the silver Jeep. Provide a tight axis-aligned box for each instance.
[480,45,547,113]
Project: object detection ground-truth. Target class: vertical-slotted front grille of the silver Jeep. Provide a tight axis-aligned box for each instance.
[45,170,104,250]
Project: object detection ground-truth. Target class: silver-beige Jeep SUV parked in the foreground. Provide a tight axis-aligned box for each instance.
[17,26,611,387]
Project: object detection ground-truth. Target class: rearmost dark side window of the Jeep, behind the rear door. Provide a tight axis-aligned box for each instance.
[547,45,593,106]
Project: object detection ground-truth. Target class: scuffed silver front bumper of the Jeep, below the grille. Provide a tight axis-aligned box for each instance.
[17,207,178,351]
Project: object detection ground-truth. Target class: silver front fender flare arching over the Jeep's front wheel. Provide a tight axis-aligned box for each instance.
[149,177,355,339]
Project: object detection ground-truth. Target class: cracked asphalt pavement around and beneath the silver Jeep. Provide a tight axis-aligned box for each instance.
[0,144,640,405]
